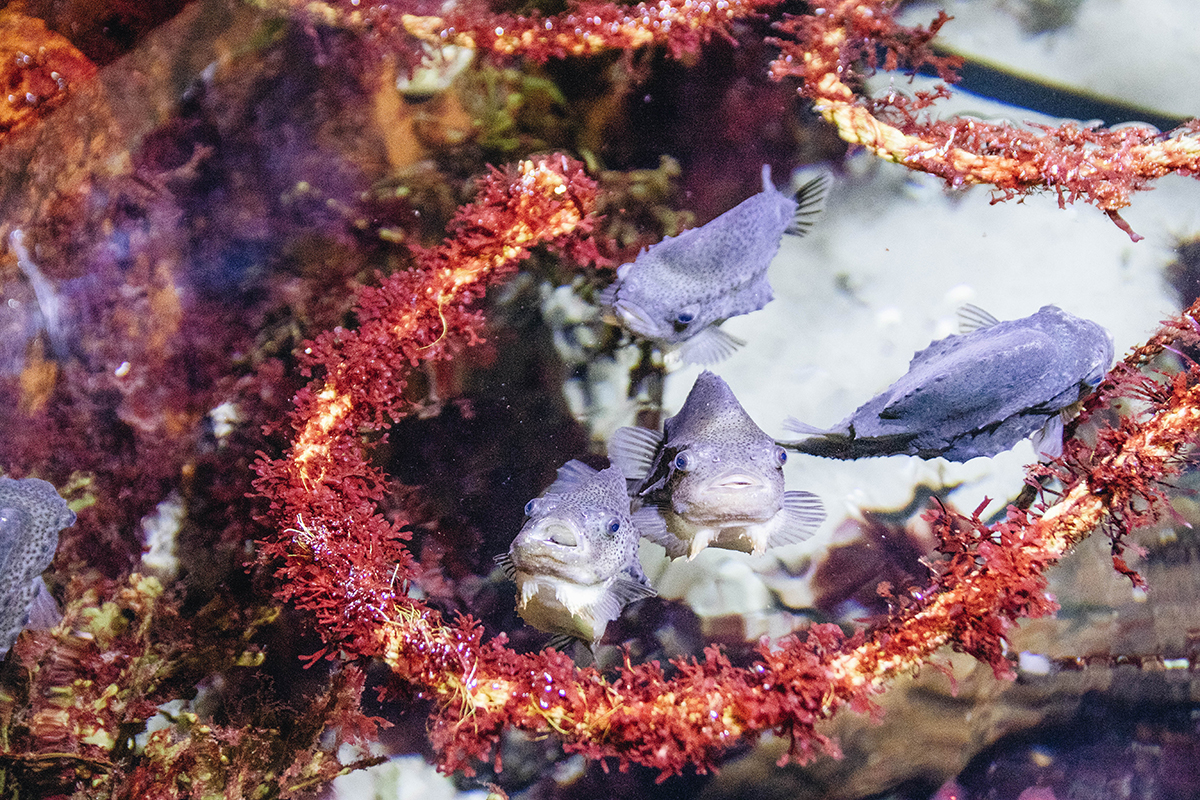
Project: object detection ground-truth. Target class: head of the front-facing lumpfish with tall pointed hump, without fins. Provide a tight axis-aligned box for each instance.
[664,371,787,522]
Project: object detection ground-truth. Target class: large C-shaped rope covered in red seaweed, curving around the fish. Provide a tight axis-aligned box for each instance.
[258,149,1200,775]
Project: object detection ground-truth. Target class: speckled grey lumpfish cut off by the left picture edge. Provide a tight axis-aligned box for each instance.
[0,476,76,657]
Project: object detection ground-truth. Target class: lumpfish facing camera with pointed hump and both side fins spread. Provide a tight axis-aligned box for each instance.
[608,369,824,558]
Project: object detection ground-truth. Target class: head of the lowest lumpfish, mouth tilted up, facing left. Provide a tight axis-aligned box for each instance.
[509,468,638,584]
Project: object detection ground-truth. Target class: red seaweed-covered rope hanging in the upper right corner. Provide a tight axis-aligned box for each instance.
[772,0,1200,241]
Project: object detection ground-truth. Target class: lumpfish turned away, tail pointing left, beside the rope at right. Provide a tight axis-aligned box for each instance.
[782,306,1114,462]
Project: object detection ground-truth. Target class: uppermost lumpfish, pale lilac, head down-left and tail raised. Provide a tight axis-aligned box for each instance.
[600,166,829,363]
